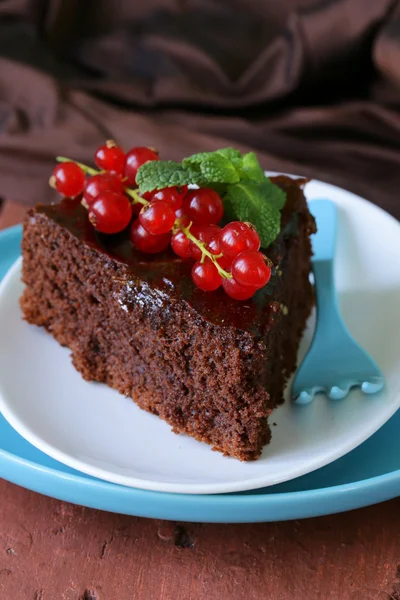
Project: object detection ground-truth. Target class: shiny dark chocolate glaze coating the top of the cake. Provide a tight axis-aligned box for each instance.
[36,176,309,337]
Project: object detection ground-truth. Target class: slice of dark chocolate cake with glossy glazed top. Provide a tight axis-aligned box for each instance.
[21,176,315,460]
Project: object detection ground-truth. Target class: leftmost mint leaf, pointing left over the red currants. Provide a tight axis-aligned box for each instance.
[136,160,198,194]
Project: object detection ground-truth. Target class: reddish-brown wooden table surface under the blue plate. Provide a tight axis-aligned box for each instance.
[0,203,400,600]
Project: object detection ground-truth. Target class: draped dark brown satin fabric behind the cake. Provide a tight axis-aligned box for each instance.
[0,0,400,215]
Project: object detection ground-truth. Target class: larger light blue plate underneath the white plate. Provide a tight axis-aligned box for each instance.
[0,226,400,523]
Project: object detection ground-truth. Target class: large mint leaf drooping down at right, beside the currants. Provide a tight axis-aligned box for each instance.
[224,180,281,248]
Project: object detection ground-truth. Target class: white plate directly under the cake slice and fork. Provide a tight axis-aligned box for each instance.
[0,181,400,494]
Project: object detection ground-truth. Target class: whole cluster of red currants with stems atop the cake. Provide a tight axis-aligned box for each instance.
[50,142,271,300]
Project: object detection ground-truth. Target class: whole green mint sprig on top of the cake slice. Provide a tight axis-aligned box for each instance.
[136,148,286,248]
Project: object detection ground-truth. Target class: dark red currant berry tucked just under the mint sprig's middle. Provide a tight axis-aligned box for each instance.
[182,188,224,225]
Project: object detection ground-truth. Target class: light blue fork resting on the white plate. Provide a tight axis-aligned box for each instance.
[292,200,384,404]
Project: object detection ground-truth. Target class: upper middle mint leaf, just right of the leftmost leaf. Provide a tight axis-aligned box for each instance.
[182,151,240,185]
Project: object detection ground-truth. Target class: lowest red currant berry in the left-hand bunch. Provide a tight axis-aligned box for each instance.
[88,190,132,233]
